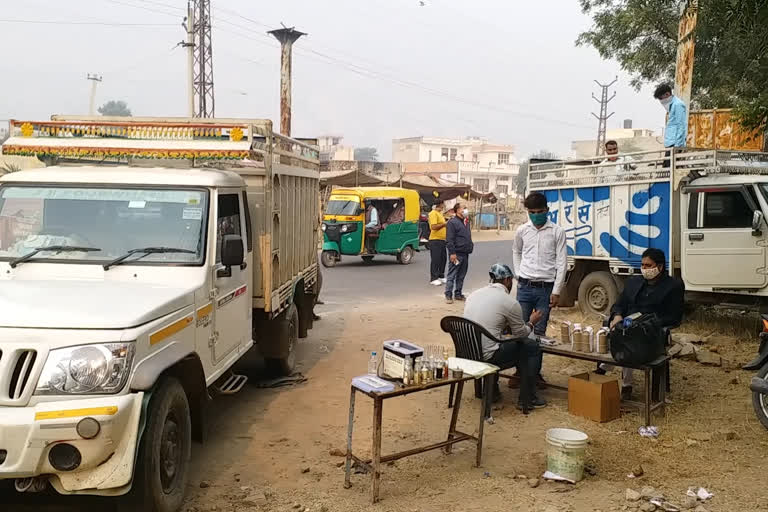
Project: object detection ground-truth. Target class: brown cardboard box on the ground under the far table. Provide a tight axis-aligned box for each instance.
[568,373,621,423]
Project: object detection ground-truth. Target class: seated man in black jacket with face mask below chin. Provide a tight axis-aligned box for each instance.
[598,248,685,400]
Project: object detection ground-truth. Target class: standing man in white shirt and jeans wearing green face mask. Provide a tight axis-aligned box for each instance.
[512,192,568,336]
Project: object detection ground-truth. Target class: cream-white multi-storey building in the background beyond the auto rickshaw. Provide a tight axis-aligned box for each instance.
[392,137,520,197]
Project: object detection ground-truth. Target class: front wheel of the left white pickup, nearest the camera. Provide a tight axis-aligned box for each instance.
[125,377,192,512]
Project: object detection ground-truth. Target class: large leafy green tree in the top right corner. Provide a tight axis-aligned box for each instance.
[577,0,768,129]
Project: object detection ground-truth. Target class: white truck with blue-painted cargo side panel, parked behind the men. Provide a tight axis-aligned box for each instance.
[528,148,768,316]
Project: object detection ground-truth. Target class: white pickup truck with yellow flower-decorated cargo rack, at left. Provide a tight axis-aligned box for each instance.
[0,118,319,512]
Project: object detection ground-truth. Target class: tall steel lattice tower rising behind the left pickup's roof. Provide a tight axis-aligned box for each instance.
[191,0,215,117]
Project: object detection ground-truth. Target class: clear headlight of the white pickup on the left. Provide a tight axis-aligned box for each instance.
[35,343,134,395]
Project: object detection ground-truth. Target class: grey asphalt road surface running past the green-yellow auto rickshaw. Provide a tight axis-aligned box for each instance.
[321,241,512,311]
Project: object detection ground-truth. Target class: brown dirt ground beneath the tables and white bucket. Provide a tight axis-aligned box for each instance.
[186,297,768,512]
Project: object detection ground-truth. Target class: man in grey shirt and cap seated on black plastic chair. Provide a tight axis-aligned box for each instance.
[464,263,547,407]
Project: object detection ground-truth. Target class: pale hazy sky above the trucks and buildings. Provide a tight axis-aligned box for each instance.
[0,0,664,160]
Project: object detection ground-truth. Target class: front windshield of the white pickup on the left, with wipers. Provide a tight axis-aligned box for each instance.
[0,185,208,265]
